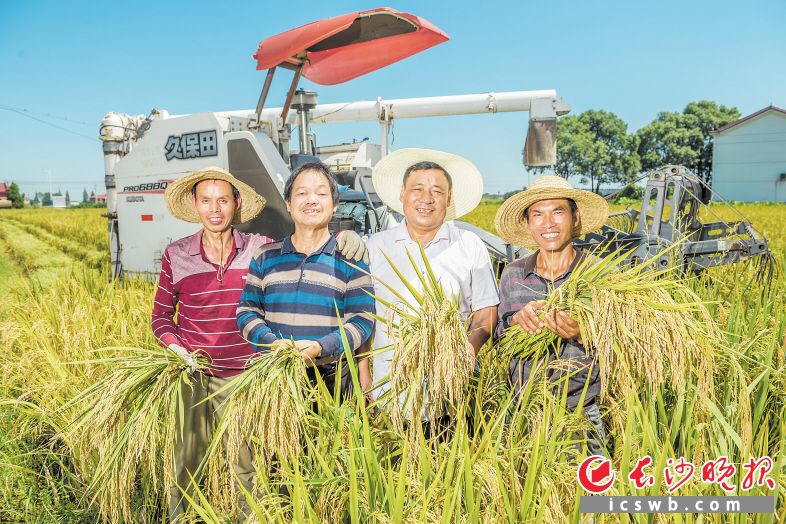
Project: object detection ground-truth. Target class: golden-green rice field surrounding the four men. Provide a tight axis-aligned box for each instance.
[0,207,786,523]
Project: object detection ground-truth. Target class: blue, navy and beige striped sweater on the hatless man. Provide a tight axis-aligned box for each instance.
[237,236,374,361]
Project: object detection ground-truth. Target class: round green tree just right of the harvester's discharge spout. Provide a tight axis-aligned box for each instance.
[555,110,641,192]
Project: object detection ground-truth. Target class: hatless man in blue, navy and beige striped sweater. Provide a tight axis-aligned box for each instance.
[237,163,374,397]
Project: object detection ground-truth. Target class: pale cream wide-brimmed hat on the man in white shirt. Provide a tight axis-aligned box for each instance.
[371,148,483,220]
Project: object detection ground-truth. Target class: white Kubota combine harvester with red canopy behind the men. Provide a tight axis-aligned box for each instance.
[100,8,767,278]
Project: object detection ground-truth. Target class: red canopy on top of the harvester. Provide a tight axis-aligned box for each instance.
[254,7,448,85]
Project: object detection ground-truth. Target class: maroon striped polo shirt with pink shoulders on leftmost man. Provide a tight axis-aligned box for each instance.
[152,229,271,377]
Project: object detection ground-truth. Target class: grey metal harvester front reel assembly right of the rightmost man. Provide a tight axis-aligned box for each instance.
[575,165,774,276]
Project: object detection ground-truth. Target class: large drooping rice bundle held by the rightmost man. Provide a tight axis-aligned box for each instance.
[501,247,721,402]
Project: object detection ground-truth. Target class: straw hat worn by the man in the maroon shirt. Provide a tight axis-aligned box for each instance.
[164,166,265,224]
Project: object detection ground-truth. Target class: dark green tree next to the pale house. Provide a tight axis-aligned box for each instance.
[636,100,740,184]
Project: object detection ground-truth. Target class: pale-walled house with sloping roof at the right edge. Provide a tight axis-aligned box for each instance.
[712,106,786,202]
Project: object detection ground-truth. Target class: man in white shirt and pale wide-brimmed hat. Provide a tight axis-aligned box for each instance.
[360,149,499,410]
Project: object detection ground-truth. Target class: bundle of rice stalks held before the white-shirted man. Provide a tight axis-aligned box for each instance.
[377,247,475,436]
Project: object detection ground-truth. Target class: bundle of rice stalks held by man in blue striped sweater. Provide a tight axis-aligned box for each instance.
[214,343,316,482]
